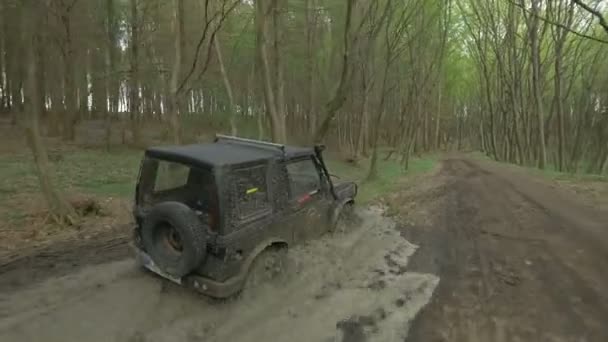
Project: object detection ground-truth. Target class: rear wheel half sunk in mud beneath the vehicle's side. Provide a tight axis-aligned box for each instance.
[244,247,288,291]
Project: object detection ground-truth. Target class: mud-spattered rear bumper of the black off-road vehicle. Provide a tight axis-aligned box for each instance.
[133,246,246,298]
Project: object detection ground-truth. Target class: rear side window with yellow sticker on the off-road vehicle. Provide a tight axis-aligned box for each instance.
[233,165,270,219]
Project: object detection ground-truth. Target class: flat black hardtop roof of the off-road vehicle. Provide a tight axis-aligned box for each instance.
[146,135,314,167]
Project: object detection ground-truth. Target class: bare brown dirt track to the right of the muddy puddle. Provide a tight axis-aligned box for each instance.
[405,159,608,342]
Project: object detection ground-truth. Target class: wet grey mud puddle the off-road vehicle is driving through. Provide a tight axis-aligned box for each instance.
[0,208,439,342]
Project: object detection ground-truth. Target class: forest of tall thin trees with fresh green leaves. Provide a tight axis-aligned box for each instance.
[0,0,608,222]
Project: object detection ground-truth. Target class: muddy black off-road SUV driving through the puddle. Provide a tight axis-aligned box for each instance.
[134,135,357,297]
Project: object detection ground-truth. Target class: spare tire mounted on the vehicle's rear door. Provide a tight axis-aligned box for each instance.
[141,202,207,278]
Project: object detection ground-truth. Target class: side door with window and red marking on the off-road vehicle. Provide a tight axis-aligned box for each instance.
[286,157,331,241]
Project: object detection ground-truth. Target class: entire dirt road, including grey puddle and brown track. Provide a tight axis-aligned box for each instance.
[0,156,608,342]
